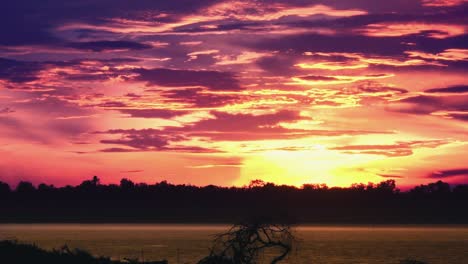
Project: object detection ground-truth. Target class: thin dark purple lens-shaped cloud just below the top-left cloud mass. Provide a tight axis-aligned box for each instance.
[67,40,152,52]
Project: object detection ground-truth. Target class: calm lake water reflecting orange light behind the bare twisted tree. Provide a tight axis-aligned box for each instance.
[0,224,468,264]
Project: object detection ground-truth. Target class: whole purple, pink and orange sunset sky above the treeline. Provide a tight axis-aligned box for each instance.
[0,0,468,186]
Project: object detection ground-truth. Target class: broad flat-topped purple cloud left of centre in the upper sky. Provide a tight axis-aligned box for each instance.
[134,68,242,90]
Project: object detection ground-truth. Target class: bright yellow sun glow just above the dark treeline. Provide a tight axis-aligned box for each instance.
[235,145,382,187]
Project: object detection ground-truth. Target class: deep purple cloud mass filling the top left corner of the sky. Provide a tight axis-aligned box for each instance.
[0,0,218,46]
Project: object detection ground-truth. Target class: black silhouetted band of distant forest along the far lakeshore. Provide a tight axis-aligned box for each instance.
[0,177,468,224]
